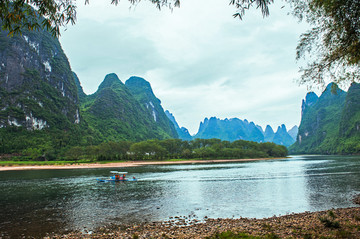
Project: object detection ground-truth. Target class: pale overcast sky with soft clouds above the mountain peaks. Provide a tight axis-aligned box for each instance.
[60,0,307,134]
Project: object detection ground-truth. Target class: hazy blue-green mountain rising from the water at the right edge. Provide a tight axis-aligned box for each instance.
[289,83,360,154]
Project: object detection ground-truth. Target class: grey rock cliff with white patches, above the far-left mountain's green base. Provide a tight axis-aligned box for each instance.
[0,27,80,130]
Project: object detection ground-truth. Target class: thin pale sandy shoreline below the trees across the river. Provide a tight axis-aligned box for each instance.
[0,157,285,171]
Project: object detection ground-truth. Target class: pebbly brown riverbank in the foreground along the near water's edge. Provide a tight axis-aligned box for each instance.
[47,207,360,238]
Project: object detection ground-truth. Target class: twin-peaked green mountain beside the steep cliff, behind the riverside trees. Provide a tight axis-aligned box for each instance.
[79,73,177,144]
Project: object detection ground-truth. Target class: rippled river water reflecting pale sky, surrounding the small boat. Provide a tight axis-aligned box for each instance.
[0,156,360,237]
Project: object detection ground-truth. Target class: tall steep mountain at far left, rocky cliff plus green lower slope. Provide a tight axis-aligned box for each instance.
[0,24,81,159]
